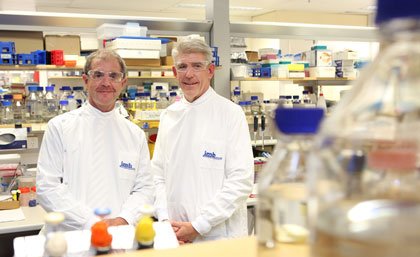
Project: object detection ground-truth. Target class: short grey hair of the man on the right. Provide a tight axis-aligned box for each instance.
[172,37,213,63]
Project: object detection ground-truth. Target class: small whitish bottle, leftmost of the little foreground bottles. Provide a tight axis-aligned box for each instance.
[45,212,67,257]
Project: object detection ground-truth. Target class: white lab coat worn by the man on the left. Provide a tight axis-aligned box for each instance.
[37,104,154,230]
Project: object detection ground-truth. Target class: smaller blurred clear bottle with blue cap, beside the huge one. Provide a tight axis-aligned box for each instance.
[257,107,324,248]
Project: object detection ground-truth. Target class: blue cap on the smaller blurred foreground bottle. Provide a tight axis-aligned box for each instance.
[276,108,324,134]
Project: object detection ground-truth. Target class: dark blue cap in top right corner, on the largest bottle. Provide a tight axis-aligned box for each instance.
[375,0,420,24]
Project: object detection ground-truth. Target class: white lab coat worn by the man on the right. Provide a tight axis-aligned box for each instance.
[152,88,254,241]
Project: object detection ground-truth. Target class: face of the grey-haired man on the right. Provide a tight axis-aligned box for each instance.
[172,53,214,103]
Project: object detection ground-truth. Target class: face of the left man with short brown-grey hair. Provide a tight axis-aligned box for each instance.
[83,59,127,112]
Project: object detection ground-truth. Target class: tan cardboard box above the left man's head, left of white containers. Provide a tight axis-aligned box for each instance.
[44,35,81,55]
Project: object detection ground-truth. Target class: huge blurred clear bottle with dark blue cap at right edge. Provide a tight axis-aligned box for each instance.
[308,0,420,257]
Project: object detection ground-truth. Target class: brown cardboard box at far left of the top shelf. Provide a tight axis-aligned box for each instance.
[0,30,44,54]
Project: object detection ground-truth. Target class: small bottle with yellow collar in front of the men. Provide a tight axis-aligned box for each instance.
[135,205,155,249]
